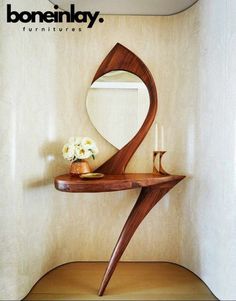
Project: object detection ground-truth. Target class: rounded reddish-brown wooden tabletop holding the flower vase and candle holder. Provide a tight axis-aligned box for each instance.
[54,173,184,192]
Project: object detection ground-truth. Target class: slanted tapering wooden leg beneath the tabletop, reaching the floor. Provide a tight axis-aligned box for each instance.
[98,180,179,296]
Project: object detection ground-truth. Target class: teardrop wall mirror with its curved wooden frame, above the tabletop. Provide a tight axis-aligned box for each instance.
[87,43,157,175]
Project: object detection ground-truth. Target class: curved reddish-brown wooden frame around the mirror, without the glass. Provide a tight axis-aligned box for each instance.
[92,43,157,174]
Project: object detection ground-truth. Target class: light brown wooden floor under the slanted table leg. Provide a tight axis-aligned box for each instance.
[25,263,217,301]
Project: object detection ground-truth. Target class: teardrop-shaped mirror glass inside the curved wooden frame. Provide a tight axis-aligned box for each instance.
[86,70,149,149]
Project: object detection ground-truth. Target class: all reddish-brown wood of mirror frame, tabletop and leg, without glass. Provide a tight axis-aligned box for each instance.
[55,44,184,296]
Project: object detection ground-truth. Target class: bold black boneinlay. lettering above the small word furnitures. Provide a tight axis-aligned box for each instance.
[7,4,104,28]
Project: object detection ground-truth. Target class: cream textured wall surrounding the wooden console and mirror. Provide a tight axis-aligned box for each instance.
[0,0,236,299]
